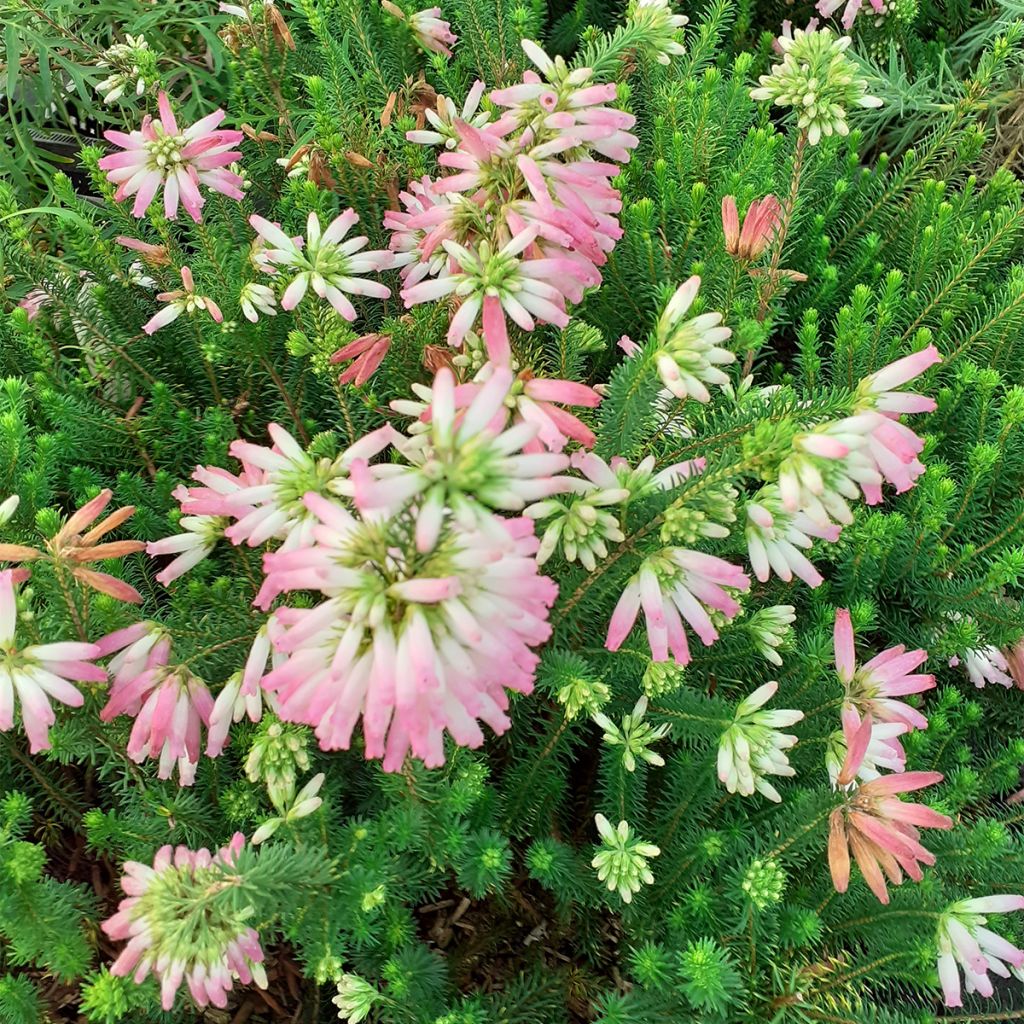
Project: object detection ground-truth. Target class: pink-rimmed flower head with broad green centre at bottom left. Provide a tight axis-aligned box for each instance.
[102,833,266,1011]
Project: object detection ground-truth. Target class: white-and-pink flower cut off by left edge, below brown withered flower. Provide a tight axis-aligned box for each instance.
[0,569,106,754]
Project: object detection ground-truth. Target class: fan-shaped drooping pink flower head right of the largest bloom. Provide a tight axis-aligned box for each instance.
[604,548,751,665]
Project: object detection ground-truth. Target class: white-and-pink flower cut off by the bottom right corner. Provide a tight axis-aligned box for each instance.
[936,896,1024,1007]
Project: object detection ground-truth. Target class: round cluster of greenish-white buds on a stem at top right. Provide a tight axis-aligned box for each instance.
[751,29,882,145]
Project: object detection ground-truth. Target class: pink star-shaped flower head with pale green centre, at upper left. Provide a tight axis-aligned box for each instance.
[99,92,242,223]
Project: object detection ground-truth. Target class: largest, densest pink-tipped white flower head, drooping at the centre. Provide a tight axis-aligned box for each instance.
[263,494,556,771]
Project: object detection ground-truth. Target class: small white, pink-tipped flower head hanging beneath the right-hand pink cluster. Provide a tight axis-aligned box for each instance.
[745,484,841,587]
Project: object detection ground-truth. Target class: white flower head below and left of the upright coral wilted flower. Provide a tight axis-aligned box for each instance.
[654,275,736,402]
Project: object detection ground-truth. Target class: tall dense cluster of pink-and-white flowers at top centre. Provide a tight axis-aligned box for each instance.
[385,30,638,364]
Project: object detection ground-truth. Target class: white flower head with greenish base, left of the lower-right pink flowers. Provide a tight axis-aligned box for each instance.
[718,682,804,804]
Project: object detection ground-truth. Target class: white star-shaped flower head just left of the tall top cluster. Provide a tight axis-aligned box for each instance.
[249,209,394,321]
